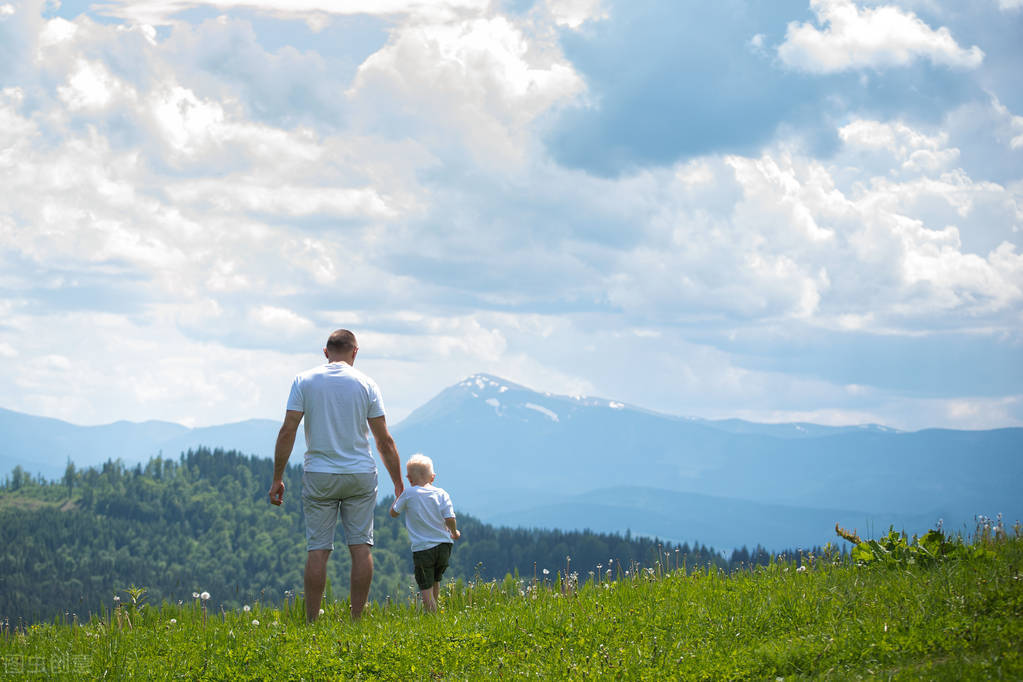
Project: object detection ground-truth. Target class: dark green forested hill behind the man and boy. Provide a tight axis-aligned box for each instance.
[0,449,768,624]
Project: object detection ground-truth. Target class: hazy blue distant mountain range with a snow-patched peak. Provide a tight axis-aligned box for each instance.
[0,374,1023,549]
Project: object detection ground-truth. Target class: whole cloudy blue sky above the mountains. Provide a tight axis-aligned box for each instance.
[0,0,1023,429]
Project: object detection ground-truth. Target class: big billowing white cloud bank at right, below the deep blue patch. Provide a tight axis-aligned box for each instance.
[607,121,1023,329]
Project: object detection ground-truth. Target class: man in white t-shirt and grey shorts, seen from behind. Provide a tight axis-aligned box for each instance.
[270,329,405,623]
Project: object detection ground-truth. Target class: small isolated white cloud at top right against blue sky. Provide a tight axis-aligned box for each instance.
[777,0,984,74]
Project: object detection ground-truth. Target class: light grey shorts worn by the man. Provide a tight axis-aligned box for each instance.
[302,471,376,551]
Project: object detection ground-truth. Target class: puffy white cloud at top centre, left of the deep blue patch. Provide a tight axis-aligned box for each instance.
[349,17,582,162]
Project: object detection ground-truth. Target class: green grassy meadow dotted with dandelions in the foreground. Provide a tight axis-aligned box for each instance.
[0,537,1023,680]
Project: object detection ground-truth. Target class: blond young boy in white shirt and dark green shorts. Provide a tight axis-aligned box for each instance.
[391,453,461,612]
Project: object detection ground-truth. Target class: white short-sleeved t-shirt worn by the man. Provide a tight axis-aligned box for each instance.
[287,362,384,473]
